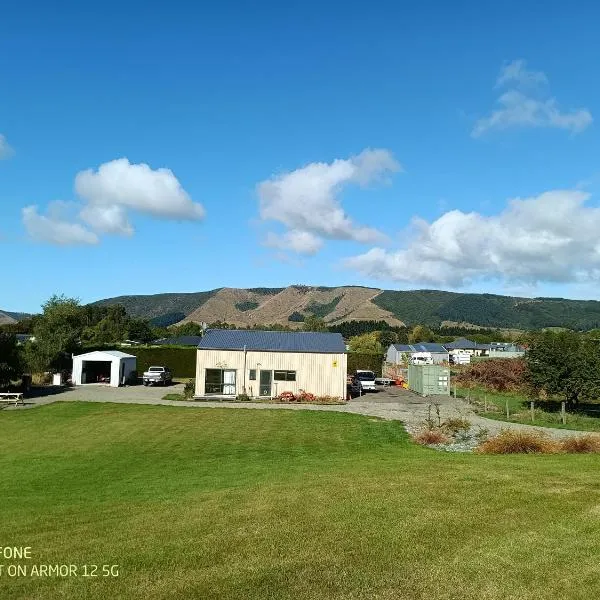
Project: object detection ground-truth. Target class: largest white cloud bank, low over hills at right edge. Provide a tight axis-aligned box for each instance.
[345,190,600,287]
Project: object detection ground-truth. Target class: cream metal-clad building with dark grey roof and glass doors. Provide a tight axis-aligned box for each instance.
[196,329,347,399]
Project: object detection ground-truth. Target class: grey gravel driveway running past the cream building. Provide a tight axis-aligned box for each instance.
[5,384,584,438]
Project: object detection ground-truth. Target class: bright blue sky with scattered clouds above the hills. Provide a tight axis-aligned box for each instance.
[0,0,600,311]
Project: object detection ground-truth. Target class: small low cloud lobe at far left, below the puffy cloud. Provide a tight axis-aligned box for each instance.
[22,206,99,246]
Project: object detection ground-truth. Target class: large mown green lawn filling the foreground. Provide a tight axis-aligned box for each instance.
[0,403,600,600]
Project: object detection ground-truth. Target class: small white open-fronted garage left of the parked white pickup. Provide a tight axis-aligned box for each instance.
[72,350,137,387]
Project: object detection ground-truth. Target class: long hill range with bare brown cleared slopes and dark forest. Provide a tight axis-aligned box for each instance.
[90,285,600,329]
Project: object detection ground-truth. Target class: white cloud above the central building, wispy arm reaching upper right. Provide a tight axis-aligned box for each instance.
[257,149,401,254]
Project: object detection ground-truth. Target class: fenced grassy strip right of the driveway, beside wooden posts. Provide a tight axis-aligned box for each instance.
[456,387,600,432]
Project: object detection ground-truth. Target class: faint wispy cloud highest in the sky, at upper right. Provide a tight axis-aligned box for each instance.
[471,60,593,137]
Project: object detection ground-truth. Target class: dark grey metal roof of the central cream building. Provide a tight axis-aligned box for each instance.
[198,329,346,354]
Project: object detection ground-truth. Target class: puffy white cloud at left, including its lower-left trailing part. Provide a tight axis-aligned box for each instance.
[23,158,204,244]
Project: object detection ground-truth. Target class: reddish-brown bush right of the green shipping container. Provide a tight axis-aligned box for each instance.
[454,358,526,392]
